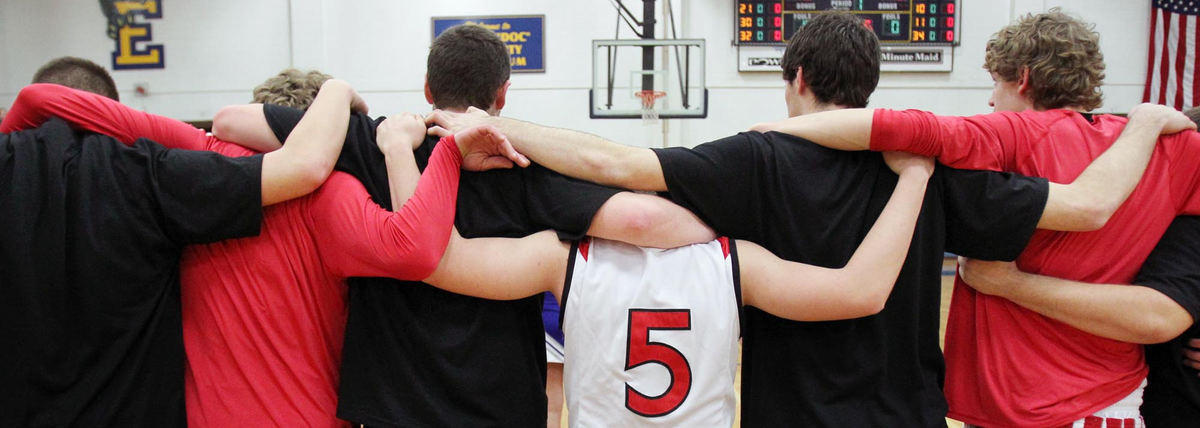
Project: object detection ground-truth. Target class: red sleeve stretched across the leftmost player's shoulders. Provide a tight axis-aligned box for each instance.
[0,83,214,150]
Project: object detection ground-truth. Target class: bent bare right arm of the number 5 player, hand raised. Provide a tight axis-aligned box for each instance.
[737,155,932,321]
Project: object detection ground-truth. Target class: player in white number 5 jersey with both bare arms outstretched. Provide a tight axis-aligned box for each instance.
[426,153,932,427]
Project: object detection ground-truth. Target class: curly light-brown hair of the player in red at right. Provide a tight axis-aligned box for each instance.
[983,7,1104,111]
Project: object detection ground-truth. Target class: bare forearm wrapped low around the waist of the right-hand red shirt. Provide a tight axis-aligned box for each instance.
[959,258,1193,344]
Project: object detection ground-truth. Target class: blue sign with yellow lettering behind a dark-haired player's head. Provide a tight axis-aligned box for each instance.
[430,14,546,72]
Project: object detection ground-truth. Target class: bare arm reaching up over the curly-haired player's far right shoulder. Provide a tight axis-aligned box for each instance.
[1038,104,1195,231]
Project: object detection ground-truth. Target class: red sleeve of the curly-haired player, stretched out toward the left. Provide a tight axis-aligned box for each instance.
[871,109,1027,170]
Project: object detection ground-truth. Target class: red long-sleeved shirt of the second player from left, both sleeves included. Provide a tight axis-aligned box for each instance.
[0,84,461,427]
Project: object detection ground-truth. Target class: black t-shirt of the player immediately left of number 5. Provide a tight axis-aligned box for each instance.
[264,106,618,427]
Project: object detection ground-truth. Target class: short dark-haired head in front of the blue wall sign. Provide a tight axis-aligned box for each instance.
[425,25,510,110]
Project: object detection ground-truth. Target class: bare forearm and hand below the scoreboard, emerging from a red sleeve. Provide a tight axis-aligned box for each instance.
[752,109,875,151]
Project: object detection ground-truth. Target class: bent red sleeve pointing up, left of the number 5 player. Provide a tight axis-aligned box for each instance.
[310,135,462,281]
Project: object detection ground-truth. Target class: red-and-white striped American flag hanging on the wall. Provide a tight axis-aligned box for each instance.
[1142,0,1200,110]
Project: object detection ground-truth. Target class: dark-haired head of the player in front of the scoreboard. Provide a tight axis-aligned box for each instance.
[781,13,880,108]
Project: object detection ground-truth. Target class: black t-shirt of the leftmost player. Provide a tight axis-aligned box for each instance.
[0,119,263,427]
